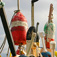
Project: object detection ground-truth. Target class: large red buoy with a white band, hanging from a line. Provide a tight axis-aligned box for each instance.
[11,11,28,45]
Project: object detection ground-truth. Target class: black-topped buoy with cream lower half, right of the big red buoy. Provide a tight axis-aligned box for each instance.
[26,26,36,52]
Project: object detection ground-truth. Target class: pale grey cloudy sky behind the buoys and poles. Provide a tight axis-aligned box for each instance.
[0,0,57,57]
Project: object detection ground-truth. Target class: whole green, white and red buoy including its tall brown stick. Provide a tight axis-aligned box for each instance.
[44,4,55,48]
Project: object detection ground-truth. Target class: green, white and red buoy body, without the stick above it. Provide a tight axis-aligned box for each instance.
[44,23,55,48]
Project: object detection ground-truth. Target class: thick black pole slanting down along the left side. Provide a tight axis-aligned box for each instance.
[0,4,16,57]
